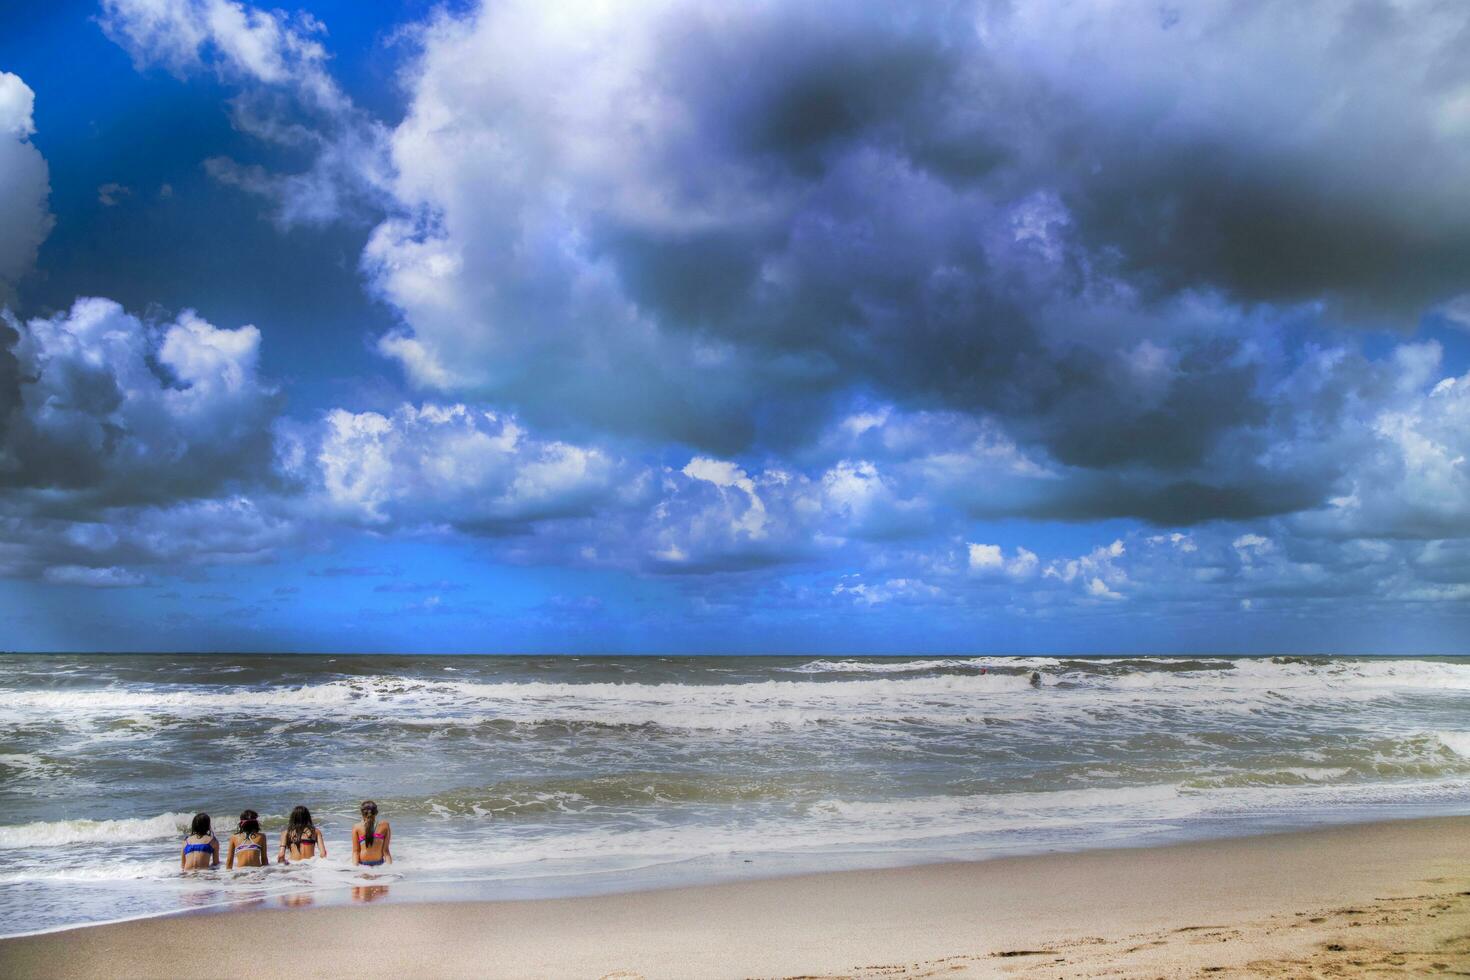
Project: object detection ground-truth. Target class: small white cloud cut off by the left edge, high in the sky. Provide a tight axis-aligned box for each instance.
[0,72,54,302]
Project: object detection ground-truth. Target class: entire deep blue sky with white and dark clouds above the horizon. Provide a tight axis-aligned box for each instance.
[0,0,1470,654]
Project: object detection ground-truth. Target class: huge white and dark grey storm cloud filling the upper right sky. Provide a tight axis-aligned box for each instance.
[346,3,1470,523]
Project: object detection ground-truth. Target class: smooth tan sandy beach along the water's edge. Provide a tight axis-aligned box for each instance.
[0,817,1470,980]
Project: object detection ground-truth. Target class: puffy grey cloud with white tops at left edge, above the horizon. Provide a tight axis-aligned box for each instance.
[0,298,295,585]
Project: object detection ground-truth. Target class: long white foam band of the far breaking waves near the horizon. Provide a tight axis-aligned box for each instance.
[0,660,1470,741]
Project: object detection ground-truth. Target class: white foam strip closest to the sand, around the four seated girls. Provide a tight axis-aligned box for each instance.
[0,779,1470,890]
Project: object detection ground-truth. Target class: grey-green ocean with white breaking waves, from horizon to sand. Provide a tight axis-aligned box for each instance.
[0,655,1470,934]
